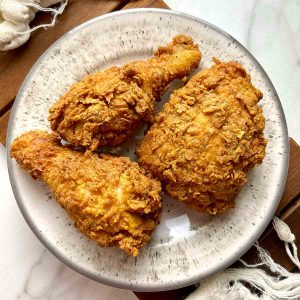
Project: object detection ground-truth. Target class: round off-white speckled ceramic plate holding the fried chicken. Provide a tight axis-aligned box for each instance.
[8,9,289,291]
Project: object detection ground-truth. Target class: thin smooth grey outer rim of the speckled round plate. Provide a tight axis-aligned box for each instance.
[7,8,290,292]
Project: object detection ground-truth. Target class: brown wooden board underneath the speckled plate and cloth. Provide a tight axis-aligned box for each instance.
[0,0,300,300]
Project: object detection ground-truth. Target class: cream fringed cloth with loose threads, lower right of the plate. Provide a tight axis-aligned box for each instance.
[186,217,300,300]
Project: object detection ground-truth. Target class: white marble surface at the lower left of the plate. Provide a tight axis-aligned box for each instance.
[0,144,137,300]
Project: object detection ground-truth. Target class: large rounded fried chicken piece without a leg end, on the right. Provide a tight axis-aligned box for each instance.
[136,59,267,214]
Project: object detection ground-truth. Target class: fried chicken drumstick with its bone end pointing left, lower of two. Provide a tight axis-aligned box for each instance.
[10,130,161,256]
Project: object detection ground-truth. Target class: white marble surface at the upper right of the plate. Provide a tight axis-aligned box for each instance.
[165,0,300,143]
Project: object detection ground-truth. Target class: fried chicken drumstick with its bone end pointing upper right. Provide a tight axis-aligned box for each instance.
[49,35,201,150]
